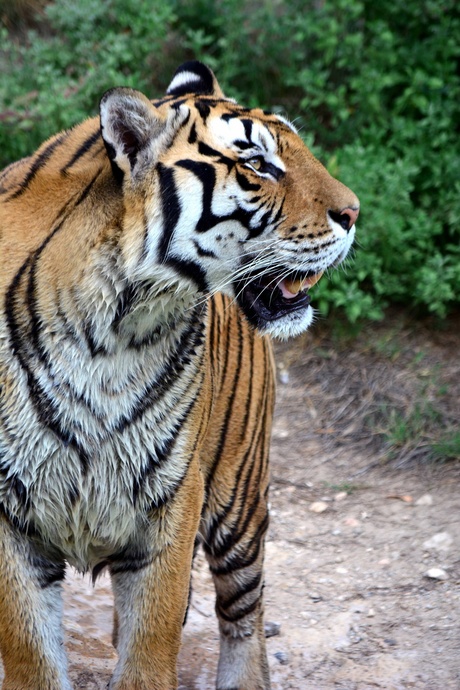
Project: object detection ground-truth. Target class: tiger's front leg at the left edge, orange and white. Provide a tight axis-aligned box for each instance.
[0,517,71,690]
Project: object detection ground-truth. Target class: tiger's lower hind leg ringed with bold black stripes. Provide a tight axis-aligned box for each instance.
[204,497,271,690]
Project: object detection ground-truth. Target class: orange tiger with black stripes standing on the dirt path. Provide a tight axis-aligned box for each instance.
[0,61,359,690]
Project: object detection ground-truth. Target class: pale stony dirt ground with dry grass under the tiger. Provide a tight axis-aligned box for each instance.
[0,314,460,690]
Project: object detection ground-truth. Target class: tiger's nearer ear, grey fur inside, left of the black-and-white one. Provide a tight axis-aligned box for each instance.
[100,87,189,181]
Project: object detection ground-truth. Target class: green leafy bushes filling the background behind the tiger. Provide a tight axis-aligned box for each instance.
[0,0,460,322]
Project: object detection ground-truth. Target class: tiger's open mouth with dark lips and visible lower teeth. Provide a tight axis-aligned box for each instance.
[235,271,323,325]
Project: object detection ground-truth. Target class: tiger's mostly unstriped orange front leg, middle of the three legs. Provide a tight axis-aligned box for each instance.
[110,456,203,690]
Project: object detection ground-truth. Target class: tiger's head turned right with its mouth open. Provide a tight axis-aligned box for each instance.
[100,62,359,337]
